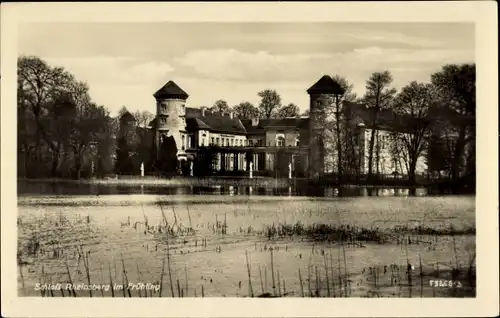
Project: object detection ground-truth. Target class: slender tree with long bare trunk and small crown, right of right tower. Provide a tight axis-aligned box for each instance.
[363,71,396,177]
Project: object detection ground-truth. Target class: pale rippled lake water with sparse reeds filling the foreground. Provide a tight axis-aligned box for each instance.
[18,185,475,297]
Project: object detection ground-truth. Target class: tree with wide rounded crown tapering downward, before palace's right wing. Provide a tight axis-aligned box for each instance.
[393,82,436,184]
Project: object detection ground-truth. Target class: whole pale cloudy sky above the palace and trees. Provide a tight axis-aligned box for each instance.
[19,22,475,114]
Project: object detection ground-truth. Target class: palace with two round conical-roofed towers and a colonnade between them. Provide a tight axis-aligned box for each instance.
[121,75,426,179]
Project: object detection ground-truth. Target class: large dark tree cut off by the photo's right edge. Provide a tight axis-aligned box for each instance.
[431,64,476,188]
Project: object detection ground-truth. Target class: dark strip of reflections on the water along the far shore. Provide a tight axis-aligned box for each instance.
[18,182,429,197]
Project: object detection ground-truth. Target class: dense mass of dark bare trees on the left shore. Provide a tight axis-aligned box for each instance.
[17,56,116,179]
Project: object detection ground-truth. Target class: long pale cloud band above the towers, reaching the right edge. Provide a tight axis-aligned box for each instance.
[174,46,474,82]
